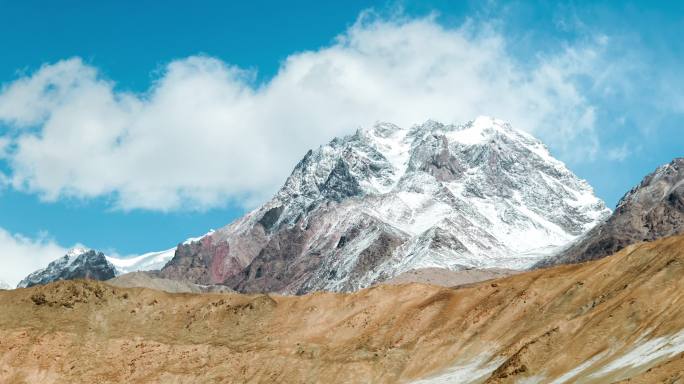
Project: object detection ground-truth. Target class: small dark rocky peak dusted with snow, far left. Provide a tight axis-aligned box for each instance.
[18,248,116,288]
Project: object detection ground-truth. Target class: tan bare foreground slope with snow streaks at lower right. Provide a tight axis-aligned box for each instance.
[0,237,684,383]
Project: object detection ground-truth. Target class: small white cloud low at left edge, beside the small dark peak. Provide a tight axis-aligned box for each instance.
[0,228,66,286]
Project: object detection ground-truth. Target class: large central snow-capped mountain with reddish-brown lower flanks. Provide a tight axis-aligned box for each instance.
[162,117,610,293]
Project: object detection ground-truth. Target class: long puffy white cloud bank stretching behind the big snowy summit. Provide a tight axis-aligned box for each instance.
[0,15,601,210]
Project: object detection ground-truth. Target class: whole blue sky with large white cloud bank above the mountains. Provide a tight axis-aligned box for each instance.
[0,0,684,282]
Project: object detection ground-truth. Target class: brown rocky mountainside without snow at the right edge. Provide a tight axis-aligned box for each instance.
[537,158,684,267]
